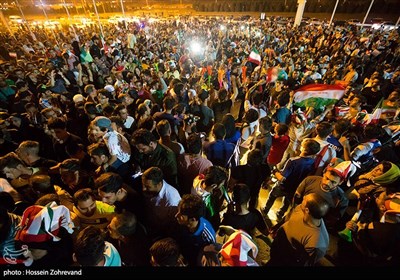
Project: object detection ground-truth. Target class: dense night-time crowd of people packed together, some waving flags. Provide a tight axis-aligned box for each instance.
[0,14,400,267]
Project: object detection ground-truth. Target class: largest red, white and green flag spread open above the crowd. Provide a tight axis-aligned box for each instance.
[293,84,345,109]
